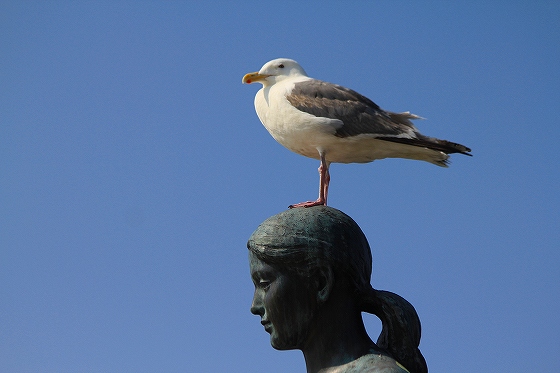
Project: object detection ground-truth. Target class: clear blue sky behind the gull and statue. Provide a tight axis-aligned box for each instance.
[0,1,560,373]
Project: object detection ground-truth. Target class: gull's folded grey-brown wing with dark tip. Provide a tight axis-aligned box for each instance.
[286,79,470,155]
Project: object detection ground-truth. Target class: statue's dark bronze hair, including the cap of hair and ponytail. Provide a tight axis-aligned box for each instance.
[247,206,428,373]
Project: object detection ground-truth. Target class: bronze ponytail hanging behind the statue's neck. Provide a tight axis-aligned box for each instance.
[362,286,428,373]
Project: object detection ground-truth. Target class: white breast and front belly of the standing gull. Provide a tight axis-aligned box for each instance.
[255,77,342,159]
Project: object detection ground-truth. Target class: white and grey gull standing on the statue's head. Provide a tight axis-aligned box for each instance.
[242,58,471,208]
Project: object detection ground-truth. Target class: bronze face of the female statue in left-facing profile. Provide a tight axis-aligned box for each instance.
[249,251,317,350]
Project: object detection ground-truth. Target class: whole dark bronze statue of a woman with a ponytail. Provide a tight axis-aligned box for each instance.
[247,206,428,373]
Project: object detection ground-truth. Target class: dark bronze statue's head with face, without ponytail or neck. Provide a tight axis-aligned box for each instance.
[248,206,371,349]
